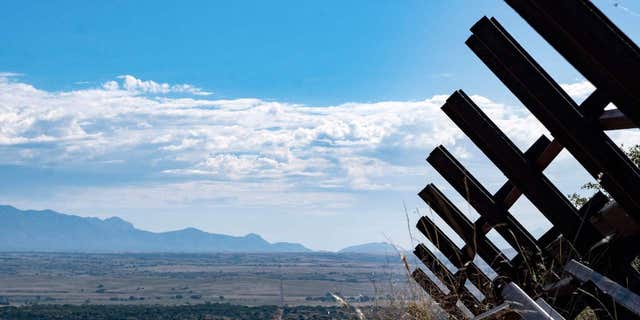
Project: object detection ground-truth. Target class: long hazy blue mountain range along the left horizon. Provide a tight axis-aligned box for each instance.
[0,206,311,252]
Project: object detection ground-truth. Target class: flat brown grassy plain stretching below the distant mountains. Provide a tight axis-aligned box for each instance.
[0,253,416,306]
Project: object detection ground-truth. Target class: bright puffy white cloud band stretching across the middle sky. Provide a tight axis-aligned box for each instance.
[0,74,568,196]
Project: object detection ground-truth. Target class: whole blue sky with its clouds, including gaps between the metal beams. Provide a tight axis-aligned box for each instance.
[0,0,640,250]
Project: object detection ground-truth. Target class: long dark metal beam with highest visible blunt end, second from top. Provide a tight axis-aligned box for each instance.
[467,17,640,220]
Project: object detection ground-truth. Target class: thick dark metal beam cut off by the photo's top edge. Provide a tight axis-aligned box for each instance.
[506,0,640,127]
